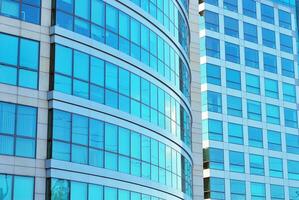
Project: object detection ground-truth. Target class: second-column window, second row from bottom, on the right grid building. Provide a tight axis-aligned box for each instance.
[229,151,245,173]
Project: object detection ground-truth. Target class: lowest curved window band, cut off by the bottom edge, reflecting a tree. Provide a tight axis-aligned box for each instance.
[47,178,163,200]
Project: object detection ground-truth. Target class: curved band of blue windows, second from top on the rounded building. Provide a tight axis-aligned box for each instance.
[53,0,190,101]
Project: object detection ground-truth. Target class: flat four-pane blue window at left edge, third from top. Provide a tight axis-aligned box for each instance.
[0,102,37,158]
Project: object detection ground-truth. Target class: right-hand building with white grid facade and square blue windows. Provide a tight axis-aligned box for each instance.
[199,0,299,200]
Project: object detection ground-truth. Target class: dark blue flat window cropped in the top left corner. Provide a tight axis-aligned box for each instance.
[0,0,41,24]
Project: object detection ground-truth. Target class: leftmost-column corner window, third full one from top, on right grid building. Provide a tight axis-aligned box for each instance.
[201,63,221,85]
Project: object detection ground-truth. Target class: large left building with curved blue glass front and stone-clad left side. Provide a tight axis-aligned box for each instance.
[0,0,201,200]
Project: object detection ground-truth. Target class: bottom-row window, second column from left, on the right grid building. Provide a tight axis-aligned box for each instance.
[230,180,246,200]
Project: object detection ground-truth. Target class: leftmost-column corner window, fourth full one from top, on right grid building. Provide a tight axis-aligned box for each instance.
[202,91,222,113]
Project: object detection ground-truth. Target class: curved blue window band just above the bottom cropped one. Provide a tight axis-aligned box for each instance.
[49,110,192,196]
